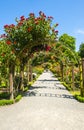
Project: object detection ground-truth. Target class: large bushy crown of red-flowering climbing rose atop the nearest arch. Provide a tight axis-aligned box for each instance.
[1,11,58,57]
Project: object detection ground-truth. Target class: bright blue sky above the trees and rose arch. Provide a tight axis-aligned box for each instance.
[0,0,84,50]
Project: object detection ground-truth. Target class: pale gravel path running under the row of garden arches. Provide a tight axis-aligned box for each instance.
[0,72,84,130]
